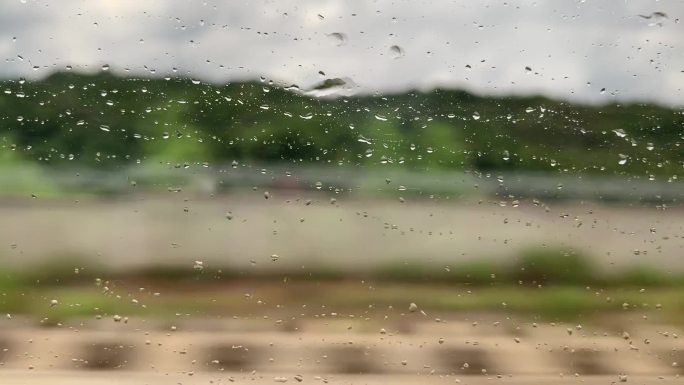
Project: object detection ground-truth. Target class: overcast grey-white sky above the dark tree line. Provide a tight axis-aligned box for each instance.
[0,0,684,106]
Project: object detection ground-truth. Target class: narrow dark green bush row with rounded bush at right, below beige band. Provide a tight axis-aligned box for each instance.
[0,247,684,289]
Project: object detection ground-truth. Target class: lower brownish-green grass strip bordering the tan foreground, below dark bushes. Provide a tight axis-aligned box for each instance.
[0,280,684,326]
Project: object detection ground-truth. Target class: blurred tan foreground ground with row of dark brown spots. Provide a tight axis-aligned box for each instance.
[0,312,684,384]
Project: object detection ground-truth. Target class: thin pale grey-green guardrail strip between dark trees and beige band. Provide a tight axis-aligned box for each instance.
[0,164,684,203]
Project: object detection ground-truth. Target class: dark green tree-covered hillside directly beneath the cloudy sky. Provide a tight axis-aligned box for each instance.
[0,73,684,176]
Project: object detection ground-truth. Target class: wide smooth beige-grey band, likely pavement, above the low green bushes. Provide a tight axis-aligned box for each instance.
[0,196,684,270]
